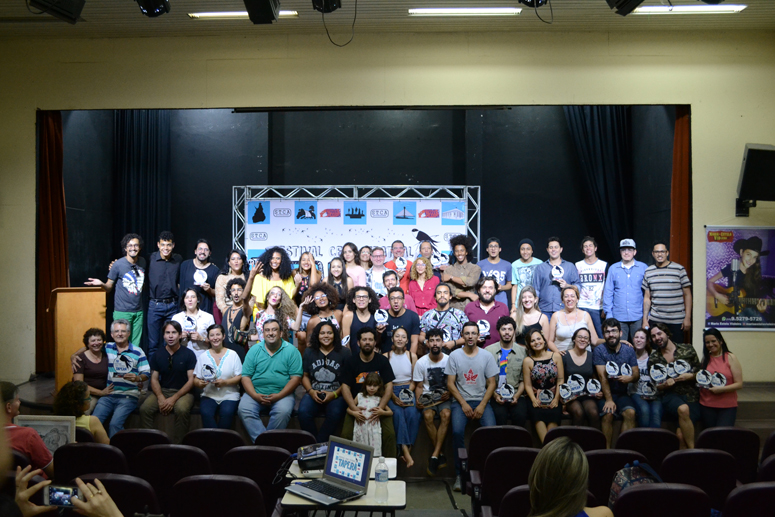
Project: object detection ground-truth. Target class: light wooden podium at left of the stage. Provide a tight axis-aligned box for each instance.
[51,287,107,391]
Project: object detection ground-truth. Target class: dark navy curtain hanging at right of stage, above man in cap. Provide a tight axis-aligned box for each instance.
[565,106,633,255]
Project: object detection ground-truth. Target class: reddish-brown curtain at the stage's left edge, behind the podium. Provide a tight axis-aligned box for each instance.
[35,111,70,372]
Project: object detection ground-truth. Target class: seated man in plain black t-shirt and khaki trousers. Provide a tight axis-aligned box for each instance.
[140,320,196,443]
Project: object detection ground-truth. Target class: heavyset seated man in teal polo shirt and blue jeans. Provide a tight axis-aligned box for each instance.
[238,319,302,442]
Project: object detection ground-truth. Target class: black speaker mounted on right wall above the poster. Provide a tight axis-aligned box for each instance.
[735,144,775,217]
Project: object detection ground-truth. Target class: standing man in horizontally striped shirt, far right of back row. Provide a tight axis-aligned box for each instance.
[643,241,692,342]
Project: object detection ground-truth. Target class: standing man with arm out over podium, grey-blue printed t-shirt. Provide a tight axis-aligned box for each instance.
[84,233,146,347]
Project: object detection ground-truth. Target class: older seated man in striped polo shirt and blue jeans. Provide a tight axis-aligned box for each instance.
[92,319,151,437]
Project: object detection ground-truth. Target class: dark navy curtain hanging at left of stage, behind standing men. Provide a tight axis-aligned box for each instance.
[113,110,172,257]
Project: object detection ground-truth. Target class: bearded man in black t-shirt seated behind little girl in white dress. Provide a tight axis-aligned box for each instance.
[342,327,396,458]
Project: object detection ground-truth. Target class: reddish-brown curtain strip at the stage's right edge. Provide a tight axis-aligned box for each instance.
[670,106,692,278]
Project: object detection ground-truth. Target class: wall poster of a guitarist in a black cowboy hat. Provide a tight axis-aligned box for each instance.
[705,226,775,331]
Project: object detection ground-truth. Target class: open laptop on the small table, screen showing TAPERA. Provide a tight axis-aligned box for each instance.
[285,436,374,505]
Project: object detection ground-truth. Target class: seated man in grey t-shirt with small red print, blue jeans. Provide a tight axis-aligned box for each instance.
[444,321,500,492]
